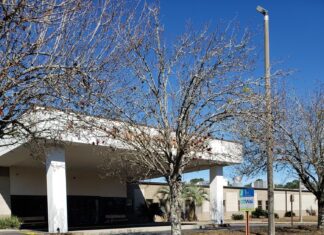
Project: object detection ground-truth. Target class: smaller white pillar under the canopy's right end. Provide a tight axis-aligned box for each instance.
[209,166,224,224]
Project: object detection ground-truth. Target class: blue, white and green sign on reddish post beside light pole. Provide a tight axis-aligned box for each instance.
[240,188,254,235]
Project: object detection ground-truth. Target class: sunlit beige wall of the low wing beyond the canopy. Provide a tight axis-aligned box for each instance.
[140,183,317,221]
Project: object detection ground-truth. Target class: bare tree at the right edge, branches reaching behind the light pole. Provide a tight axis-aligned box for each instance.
[236,84,324,228]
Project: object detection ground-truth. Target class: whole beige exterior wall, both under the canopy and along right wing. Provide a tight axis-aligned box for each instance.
[6,166,317,221]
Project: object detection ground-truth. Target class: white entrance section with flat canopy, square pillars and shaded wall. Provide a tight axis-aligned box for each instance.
[0,108,242,232]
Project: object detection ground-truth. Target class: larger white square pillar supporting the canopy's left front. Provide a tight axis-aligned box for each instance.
[46,146,68,233]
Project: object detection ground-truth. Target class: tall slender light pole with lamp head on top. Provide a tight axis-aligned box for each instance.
[257,6,275,235]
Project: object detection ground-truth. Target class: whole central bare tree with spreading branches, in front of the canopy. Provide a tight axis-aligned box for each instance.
[80,6,259,234]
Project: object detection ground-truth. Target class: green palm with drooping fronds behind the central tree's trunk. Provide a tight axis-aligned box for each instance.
[156,183,209,221]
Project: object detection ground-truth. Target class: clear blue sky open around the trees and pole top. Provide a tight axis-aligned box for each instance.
[147,0,324,183]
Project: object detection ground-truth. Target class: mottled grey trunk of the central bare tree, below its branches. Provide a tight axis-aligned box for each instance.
[169,180,182,235]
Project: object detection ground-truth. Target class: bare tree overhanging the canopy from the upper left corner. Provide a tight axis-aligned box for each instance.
[0,0,138,144]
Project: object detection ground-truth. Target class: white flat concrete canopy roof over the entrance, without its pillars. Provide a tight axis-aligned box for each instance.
[0,108,242,175]
